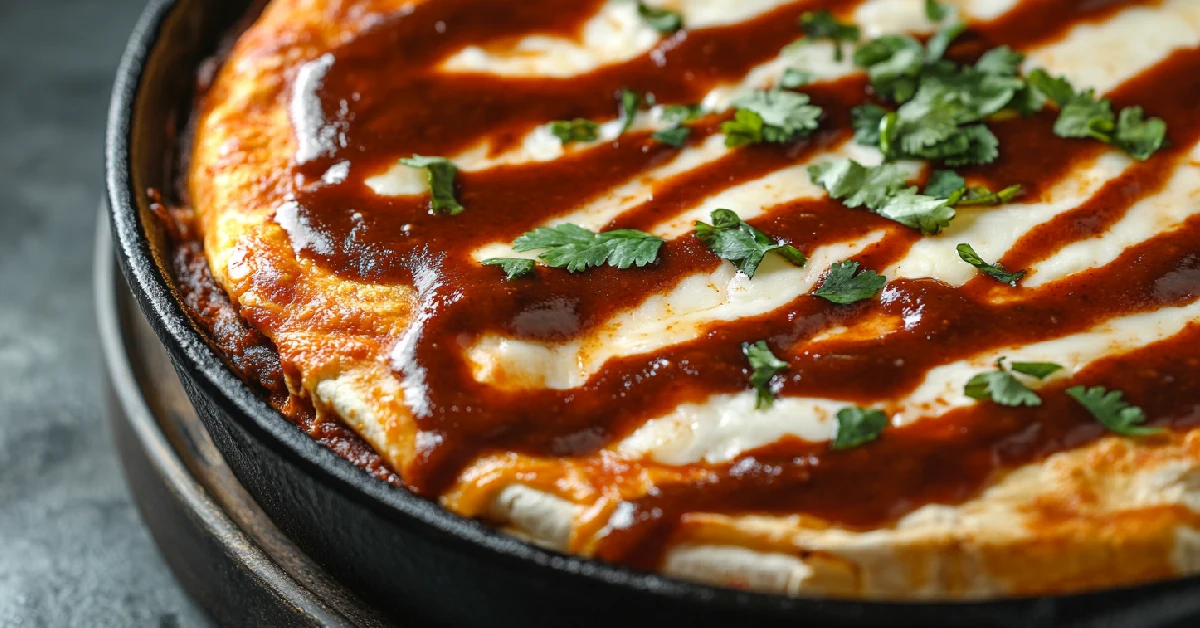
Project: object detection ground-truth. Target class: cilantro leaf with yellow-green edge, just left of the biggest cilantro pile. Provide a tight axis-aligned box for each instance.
[721,91,821,146]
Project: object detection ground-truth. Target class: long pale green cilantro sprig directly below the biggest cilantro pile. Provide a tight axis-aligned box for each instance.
[809,160,958,235]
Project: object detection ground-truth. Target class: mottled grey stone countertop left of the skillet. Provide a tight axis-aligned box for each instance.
[0,0,208,628]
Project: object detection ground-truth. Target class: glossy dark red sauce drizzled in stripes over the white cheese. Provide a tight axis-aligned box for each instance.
[185,0,1200,563]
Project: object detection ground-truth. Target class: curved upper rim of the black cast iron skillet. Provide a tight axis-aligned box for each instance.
[104,0,1200,622]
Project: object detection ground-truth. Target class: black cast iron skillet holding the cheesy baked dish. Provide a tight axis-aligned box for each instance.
[106,0,1200,627]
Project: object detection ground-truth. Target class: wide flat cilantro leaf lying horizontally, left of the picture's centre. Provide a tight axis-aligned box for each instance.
[512,223,662,273]
